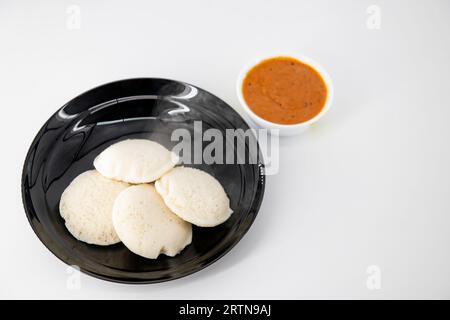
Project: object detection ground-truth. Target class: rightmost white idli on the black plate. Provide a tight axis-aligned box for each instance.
[155,167,233,227]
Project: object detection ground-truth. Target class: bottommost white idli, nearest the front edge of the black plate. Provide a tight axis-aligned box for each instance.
[113,184,192,259]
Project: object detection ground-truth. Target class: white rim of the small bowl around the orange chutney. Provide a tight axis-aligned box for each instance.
[236,52,334,130]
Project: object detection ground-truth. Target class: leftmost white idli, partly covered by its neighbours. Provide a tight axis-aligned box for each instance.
[59,170,129,245]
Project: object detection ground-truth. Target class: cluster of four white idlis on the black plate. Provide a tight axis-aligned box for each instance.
[59,139,233,259]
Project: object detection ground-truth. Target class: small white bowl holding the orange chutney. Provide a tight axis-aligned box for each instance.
[237,54,334,136]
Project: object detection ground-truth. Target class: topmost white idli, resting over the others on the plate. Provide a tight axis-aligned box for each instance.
[94,139,178,183]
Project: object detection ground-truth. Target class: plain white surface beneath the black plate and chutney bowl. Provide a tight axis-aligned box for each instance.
[0,0,450,299]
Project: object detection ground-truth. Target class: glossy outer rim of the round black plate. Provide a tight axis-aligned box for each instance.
[21,77,265,284]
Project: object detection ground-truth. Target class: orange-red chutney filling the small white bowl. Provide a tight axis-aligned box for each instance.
[242,56,328,124]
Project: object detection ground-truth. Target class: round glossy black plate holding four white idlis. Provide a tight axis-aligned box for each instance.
[22,78,264,283]
